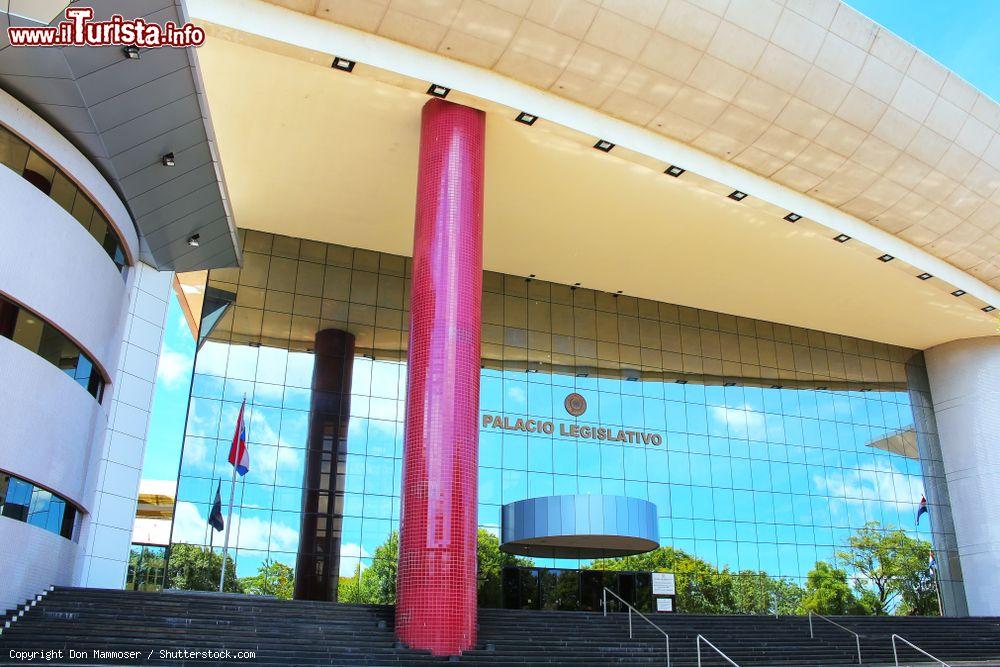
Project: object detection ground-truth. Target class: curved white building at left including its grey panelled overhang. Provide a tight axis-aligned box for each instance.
[0,3,235,609]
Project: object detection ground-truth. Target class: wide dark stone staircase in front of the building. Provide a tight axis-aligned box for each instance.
[0,588,1000,667]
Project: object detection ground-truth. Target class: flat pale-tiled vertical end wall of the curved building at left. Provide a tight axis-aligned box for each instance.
[76,263,173,588]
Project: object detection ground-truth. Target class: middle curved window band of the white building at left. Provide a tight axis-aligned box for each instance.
[0,296,105,403]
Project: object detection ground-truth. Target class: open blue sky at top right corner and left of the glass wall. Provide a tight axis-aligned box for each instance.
[143,0,1000,481]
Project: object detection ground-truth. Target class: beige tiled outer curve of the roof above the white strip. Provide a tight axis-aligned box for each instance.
[252,0,1000,298]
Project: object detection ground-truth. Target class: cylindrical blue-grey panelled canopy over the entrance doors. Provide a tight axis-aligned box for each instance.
[500,495,660,558]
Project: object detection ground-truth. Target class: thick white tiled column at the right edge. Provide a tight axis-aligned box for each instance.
[924,336,1000,616]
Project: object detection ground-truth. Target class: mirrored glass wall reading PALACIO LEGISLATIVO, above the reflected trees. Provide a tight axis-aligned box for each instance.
[172,231,960,616]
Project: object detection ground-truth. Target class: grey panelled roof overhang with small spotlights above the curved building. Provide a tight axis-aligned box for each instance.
[0,0,239,271]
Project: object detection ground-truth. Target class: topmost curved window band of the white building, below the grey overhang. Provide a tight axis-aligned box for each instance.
[0,125,128,272]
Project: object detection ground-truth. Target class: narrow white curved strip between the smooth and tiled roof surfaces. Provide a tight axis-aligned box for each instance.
[187,0,1000,308]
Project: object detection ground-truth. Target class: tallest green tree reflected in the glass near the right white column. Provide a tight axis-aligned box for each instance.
[837,521,937,615]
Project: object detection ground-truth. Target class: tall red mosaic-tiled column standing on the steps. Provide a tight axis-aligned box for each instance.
[396,99,486,655]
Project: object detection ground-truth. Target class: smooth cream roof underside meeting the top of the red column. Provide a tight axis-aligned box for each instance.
[186,34,996,349]
